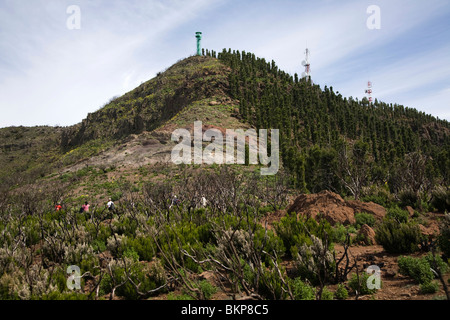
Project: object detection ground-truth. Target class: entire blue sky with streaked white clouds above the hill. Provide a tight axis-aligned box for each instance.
[0,0,450,127]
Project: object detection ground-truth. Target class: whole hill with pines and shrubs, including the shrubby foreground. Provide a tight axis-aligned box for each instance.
[0,50,450,300]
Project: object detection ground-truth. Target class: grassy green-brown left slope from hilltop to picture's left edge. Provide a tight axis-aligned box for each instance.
[0,57,238,192]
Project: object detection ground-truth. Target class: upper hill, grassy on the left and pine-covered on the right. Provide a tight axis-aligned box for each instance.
[0,50,450,197]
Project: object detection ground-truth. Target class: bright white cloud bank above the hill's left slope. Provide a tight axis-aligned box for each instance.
[0,0,225,127]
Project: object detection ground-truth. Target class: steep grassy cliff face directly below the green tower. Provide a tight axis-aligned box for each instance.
[61,56,229,149]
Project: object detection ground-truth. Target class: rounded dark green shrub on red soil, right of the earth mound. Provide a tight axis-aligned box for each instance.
[375,218,422,253]
